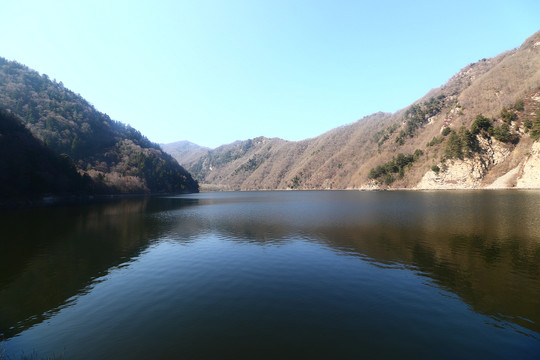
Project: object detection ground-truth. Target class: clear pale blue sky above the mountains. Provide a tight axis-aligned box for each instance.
[0,0,540,147]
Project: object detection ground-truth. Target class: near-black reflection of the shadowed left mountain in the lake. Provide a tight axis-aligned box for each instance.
[0,198,200,337]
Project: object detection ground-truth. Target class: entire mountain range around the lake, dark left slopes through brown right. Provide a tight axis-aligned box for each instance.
[0,31,540,204]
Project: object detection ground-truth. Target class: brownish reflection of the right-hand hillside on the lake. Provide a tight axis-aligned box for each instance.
[166,191,540,332]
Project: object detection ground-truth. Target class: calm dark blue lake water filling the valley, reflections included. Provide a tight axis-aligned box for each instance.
[0,191,540,359]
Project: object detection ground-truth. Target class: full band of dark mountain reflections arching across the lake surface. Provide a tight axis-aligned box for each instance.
[0,191,540,358]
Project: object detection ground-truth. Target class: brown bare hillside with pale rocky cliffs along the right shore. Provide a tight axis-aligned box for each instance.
[166,32,540,190]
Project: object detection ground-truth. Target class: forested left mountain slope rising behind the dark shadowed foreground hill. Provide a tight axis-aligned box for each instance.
[0,58,198,197]
